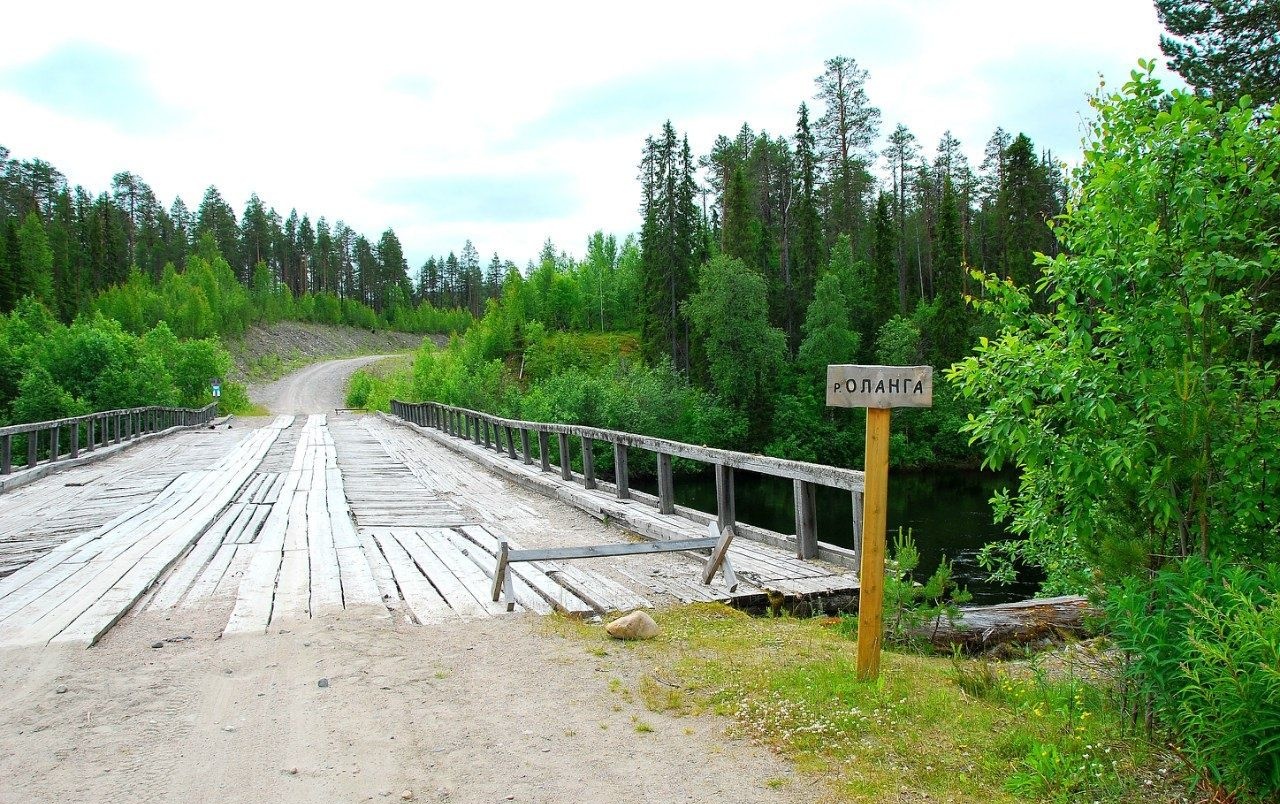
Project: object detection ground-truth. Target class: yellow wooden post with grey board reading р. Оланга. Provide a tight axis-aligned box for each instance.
[827,365,933,680]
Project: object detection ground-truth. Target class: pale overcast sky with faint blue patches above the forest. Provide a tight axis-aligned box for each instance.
[0,0,1177,270]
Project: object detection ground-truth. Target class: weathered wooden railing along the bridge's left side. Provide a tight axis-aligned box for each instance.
[0,402,218,475]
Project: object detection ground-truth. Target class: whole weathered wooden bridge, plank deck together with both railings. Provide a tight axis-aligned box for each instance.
[0,386,861,647]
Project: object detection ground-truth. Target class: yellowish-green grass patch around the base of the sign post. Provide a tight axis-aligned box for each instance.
[549,604,1175,804]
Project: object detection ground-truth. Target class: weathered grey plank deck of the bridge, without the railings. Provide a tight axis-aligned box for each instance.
[0,399,856,647]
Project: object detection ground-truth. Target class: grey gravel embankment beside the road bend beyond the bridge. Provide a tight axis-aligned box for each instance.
[227,321,443,383]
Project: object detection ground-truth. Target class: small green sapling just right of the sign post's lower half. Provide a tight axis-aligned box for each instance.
[884,527,973,647]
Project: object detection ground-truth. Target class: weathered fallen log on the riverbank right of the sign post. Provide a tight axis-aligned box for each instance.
[919,595,1096,653]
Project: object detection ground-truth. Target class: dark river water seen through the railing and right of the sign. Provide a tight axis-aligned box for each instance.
[631,471,1038,604]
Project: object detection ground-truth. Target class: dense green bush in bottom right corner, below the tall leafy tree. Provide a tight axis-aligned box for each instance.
[1106,558,1280,800]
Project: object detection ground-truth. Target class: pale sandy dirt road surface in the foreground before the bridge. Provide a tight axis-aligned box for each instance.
[0,615,798,804]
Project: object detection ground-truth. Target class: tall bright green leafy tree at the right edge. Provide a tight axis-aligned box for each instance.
[950,65,1280,591]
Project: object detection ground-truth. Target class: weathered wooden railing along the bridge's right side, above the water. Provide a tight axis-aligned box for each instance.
[392,399,863,566]
